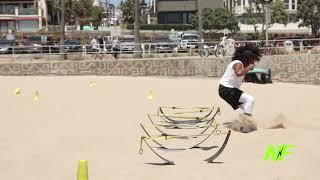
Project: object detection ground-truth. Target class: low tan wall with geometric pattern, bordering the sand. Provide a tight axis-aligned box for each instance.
[0,54,320,84]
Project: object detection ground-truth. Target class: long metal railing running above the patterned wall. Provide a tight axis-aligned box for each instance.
[0,39,320,59]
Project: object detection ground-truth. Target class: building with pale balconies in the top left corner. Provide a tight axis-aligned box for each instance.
[0,0,48,32]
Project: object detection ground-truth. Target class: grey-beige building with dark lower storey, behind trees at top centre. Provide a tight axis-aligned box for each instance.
[156,0,224,24]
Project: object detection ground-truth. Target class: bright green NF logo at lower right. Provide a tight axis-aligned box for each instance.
[263,144,295,161]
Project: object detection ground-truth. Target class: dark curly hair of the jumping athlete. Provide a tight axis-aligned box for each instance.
[232,44,261,64]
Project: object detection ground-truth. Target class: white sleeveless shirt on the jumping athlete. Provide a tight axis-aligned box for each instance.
[220,60,244,89]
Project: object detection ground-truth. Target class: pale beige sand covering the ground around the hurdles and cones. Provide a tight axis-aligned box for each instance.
[0,76,320,180]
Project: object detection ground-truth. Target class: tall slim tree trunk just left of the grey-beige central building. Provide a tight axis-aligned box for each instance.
[134,0,142,58]
